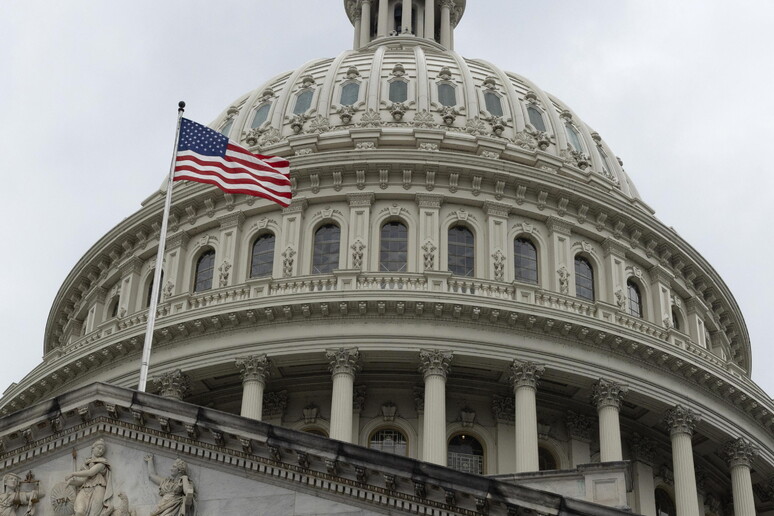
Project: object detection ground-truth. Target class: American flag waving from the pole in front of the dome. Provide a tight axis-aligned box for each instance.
[173,118,291,206]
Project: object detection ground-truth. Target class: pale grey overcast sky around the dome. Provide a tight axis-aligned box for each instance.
[0,0,774,400]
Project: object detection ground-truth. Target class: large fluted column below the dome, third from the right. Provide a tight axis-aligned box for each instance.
[591,378,629,462]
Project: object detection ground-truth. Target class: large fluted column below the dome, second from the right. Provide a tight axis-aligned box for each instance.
[664,405,700,516]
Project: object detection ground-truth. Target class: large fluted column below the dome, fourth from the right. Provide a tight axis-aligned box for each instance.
[511,360,545,473]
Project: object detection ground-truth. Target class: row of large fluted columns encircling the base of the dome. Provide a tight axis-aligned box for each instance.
[155,348,758,516]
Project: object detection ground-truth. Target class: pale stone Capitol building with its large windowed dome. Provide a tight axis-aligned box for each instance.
[0,0,774,516]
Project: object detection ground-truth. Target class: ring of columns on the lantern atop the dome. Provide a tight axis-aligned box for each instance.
[351,0,457,50]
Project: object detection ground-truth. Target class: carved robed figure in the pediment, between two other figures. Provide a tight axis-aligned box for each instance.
[65,439,113,516]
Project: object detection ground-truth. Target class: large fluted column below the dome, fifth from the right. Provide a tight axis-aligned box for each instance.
[419,349,453,466]
